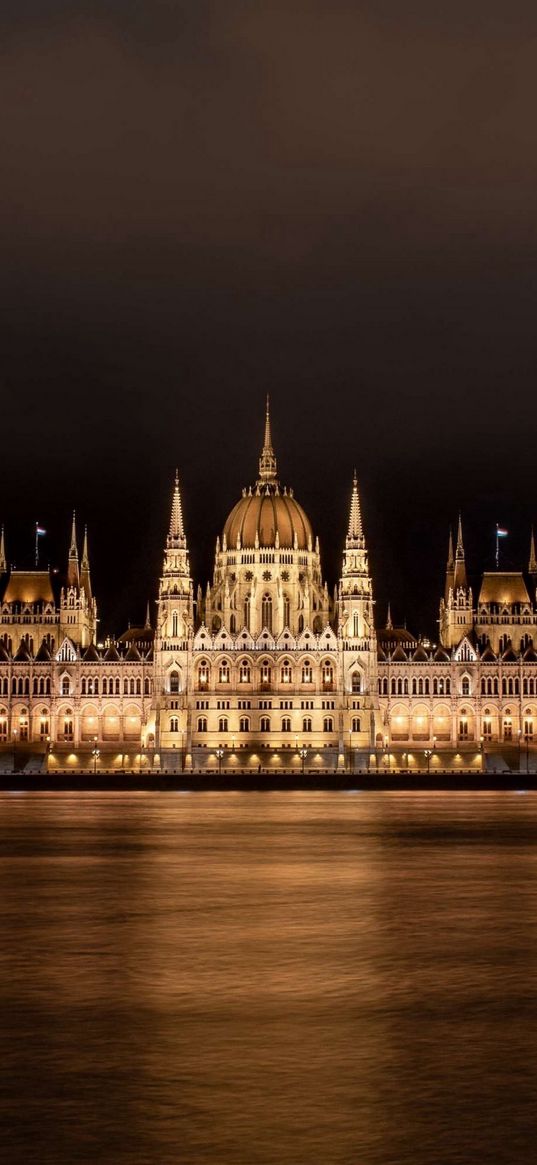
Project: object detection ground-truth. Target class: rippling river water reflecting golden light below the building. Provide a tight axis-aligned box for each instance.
[0,792,537,1165]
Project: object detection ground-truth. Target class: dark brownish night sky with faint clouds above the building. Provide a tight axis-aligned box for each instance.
[0,0,537,633]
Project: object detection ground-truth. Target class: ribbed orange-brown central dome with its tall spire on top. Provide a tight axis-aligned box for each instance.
[224,400,313,550]
